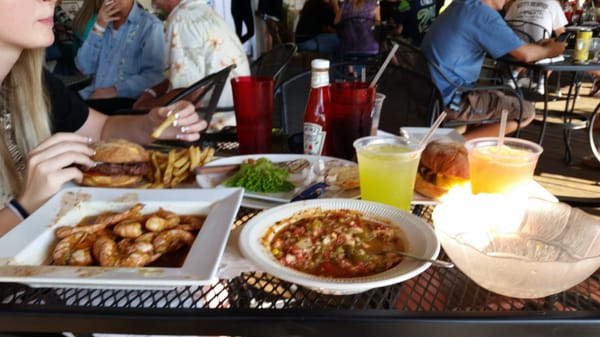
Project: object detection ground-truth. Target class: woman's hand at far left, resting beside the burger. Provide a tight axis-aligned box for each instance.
[17,133,94,213]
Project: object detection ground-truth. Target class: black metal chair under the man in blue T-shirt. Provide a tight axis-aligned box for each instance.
[390,38,523,137]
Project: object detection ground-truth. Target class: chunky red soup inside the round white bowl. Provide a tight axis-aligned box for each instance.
[263,209,408,277]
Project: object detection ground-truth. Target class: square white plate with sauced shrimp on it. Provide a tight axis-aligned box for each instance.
[0,187,243,289]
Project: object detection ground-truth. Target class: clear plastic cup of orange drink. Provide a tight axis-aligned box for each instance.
[465,137,543,195]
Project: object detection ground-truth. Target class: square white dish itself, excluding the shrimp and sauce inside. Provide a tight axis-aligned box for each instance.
[0,188,243,288]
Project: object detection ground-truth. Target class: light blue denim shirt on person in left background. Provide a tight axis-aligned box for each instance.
[75,4,166,99]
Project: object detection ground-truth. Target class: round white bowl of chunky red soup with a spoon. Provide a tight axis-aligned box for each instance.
[239,198,440,295]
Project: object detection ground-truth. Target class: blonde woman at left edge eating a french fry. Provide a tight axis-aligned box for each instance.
[0,0,206,236]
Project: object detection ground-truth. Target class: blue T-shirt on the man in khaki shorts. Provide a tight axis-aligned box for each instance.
[421,0,524,105]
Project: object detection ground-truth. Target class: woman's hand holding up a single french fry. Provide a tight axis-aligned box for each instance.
[148,101,207,142]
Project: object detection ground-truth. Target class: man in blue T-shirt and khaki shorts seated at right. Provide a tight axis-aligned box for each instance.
[421,0,567,139]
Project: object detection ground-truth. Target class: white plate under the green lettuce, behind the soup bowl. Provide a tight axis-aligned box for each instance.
[196,154,360,208]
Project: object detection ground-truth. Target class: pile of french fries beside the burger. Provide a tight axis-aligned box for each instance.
[140,145,215,188]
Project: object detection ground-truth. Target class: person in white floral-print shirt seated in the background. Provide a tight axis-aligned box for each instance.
[133,0,250,131]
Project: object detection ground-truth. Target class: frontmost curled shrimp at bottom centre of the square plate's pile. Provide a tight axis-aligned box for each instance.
[92,236,160,267]
